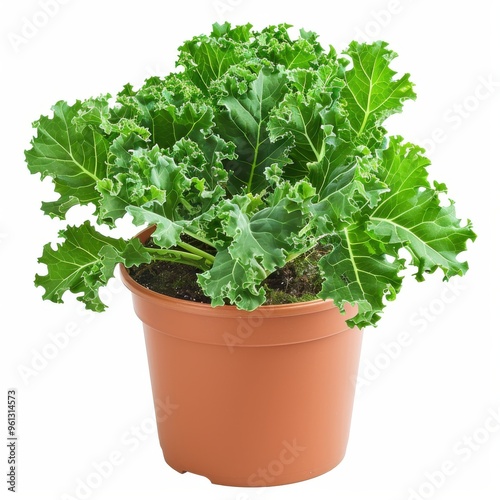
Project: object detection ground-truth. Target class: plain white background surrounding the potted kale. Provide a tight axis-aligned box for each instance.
[0,0,500,500]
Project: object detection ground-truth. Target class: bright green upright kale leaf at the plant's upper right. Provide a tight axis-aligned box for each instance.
[341,42,416,136]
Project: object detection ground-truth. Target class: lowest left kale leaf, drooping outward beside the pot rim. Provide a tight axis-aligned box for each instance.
[35,221,151,311]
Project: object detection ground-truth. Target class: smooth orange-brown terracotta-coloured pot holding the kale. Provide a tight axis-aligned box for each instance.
[121,229,362,486]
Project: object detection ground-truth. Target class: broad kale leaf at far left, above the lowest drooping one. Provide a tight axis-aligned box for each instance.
[25,101,109,218]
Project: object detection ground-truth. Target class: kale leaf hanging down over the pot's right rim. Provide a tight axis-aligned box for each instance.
[319,225,404,328]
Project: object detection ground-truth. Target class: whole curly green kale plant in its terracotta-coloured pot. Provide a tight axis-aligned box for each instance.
[26,23,475,486]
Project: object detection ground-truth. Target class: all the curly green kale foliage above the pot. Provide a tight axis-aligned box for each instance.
[26,23,475,326]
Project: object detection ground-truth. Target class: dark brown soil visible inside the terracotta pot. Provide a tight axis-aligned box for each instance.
[129,238,326,305]
